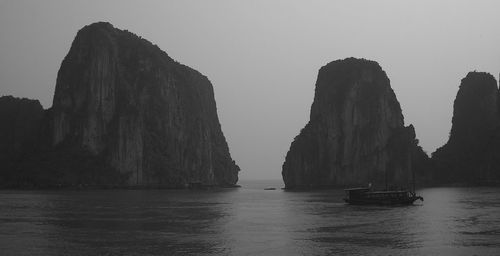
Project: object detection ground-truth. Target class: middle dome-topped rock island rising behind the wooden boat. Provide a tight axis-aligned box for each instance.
[282,58,425,188]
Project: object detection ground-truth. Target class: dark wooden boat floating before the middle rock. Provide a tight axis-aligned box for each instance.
[344,187,424,205]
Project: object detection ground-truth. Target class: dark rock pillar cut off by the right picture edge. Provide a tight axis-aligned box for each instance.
[432,72,500,184]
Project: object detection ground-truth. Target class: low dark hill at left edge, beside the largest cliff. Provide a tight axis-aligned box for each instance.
[0,96,44,184]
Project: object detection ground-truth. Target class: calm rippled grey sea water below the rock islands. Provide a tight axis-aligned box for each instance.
[0,182,500,255]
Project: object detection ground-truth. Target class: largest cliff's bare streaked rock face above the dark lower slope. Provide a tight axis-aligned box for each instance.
[50,23,239,186]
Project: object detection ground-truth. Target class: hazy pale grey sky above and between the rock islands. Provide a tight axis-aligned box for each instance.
[0,0,500,179]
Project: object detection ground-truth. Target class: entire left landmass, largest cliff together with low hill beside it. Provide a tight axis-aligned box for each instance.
[0,22,239,187]
